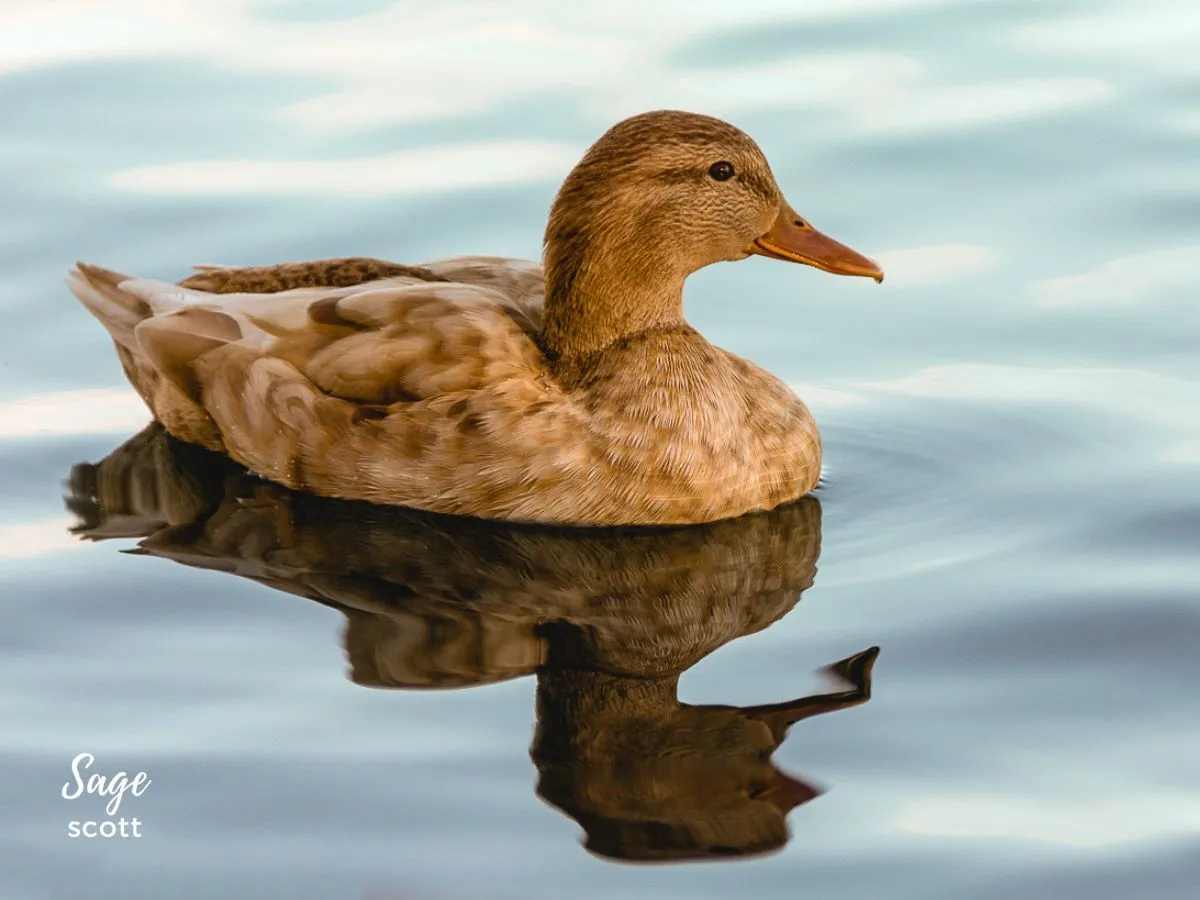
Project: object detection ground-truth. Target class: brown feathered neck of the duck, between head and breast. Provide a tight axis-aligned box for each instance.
[541,227,684,365]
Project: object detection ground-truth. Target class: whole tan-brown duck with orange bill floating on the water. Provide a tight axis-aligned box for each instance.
[67,110,883,527]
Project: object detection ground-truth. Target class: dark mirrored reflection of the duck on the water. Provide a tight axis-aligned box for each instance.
[66,425,878,862]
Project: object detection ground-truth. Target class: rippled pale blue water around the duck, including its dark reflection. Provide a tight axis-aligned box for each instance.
[0,0,1200,900]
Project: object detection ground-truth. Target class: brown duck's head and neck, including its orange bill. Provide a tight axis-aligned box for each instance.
[544,110,883,362]
